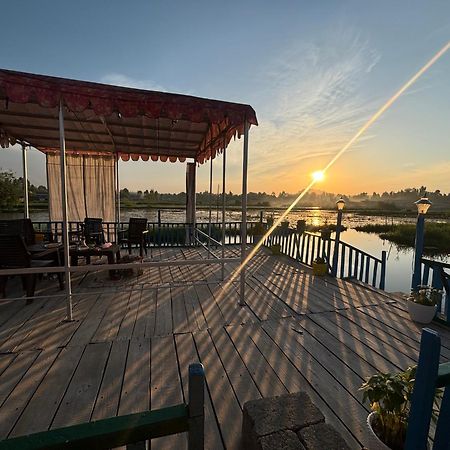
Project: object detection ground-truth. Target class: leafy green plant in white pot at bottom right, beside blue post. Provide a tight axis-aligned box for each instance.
[360,366,442,450]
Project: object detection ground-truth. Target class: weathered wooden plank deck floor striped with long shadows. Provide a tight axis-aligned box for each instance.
[0,248,450,449]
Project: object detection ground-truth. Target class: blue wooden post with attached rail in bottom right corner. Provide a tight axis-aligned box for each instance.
[405,328,450,450]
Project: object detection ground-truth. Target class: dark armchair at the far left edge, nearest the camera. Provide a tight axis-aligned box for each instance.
[0,234,64,303]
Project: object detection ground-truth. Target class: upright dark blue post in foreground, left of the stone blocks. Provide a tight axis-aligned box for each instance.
[188,363,205,450]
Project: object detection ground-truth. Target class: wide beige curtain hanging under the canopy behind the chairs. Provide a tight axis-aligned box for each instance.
[47,154,116,222]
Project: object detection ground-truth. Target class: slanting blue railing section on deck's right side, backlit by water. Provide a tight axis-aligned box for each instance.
[264,227,386,289]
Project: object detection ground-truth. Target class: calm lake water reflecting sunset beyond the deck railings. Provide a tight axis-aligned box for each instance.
[0,208,450,292]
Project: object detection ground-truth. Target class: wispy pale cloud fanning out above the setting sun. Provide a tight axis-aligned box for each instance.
[251,29,381,190]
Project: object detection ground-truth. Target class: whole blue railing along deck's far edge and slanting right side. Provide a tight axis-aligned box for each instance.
[30,221,386,289]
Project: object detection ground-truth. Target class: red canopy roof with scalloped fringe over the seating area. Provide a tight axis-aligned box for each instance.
[0,69,258,163]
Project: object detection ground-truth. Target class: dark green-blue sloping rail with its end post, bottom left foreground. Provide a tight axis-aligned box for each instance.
[0,364,205,450]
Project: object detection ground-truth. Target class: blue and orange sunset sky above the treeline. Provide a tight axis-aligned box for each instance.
[0,0,450,194]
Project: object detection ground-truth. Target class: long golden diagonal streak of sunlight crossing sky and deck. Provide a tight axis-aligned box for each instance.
[219,41,450,306]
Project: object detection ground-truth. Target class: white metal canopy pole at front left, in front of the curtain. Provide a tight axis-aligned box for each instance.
[59,100,73,321]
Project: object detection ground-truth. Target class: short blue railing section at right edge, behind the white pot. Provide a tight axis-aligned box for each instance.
[421,258,450,325]
